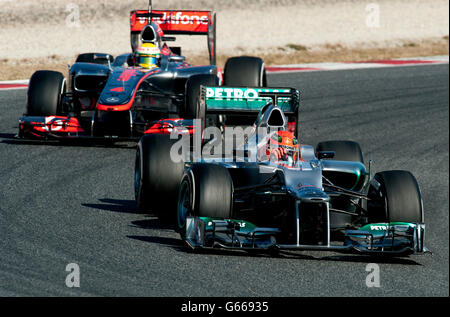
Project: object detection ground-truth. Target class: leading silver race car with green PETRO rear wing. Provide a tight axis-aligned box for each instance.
[134,86,428,256]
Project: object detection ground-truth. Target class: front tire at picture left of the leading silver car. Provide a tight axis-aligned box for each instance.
[177,163,233,239]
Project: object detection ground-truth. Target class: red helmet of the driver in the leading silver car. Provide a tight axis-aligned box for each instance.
[267,130,298,165]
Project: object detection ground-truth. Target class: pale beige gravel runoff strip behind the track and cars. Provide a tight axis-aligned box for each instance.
[0,0,449,80]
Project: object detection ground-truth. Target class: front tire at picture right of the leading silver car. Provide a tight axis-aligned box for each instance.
[368,170,423,223]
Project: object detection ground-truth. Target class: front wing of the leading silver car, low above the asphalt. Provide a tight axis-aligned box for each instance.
[185,217,430,256]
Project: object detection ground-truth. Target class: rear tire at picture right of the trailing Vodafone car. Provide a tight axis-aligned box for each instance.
[223,56,267,87]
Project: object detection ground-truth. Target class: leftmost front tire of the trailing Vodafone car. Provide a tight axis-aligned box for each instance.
[27,70,66,116]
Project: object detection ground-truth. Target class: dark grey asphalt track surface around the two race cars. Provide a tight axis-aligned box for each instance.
[0,65,449,297]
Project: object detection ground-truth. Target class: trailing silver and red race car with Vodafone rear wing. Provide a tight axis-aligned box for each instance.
[18,1,266,139]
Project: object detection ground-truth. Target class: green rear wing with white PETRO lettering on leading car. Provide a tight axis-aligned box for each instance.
[200,86,300,118]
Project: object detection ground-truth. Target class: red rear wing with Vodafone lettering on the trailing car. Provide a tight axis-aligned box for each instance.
[130,10,216,65]
